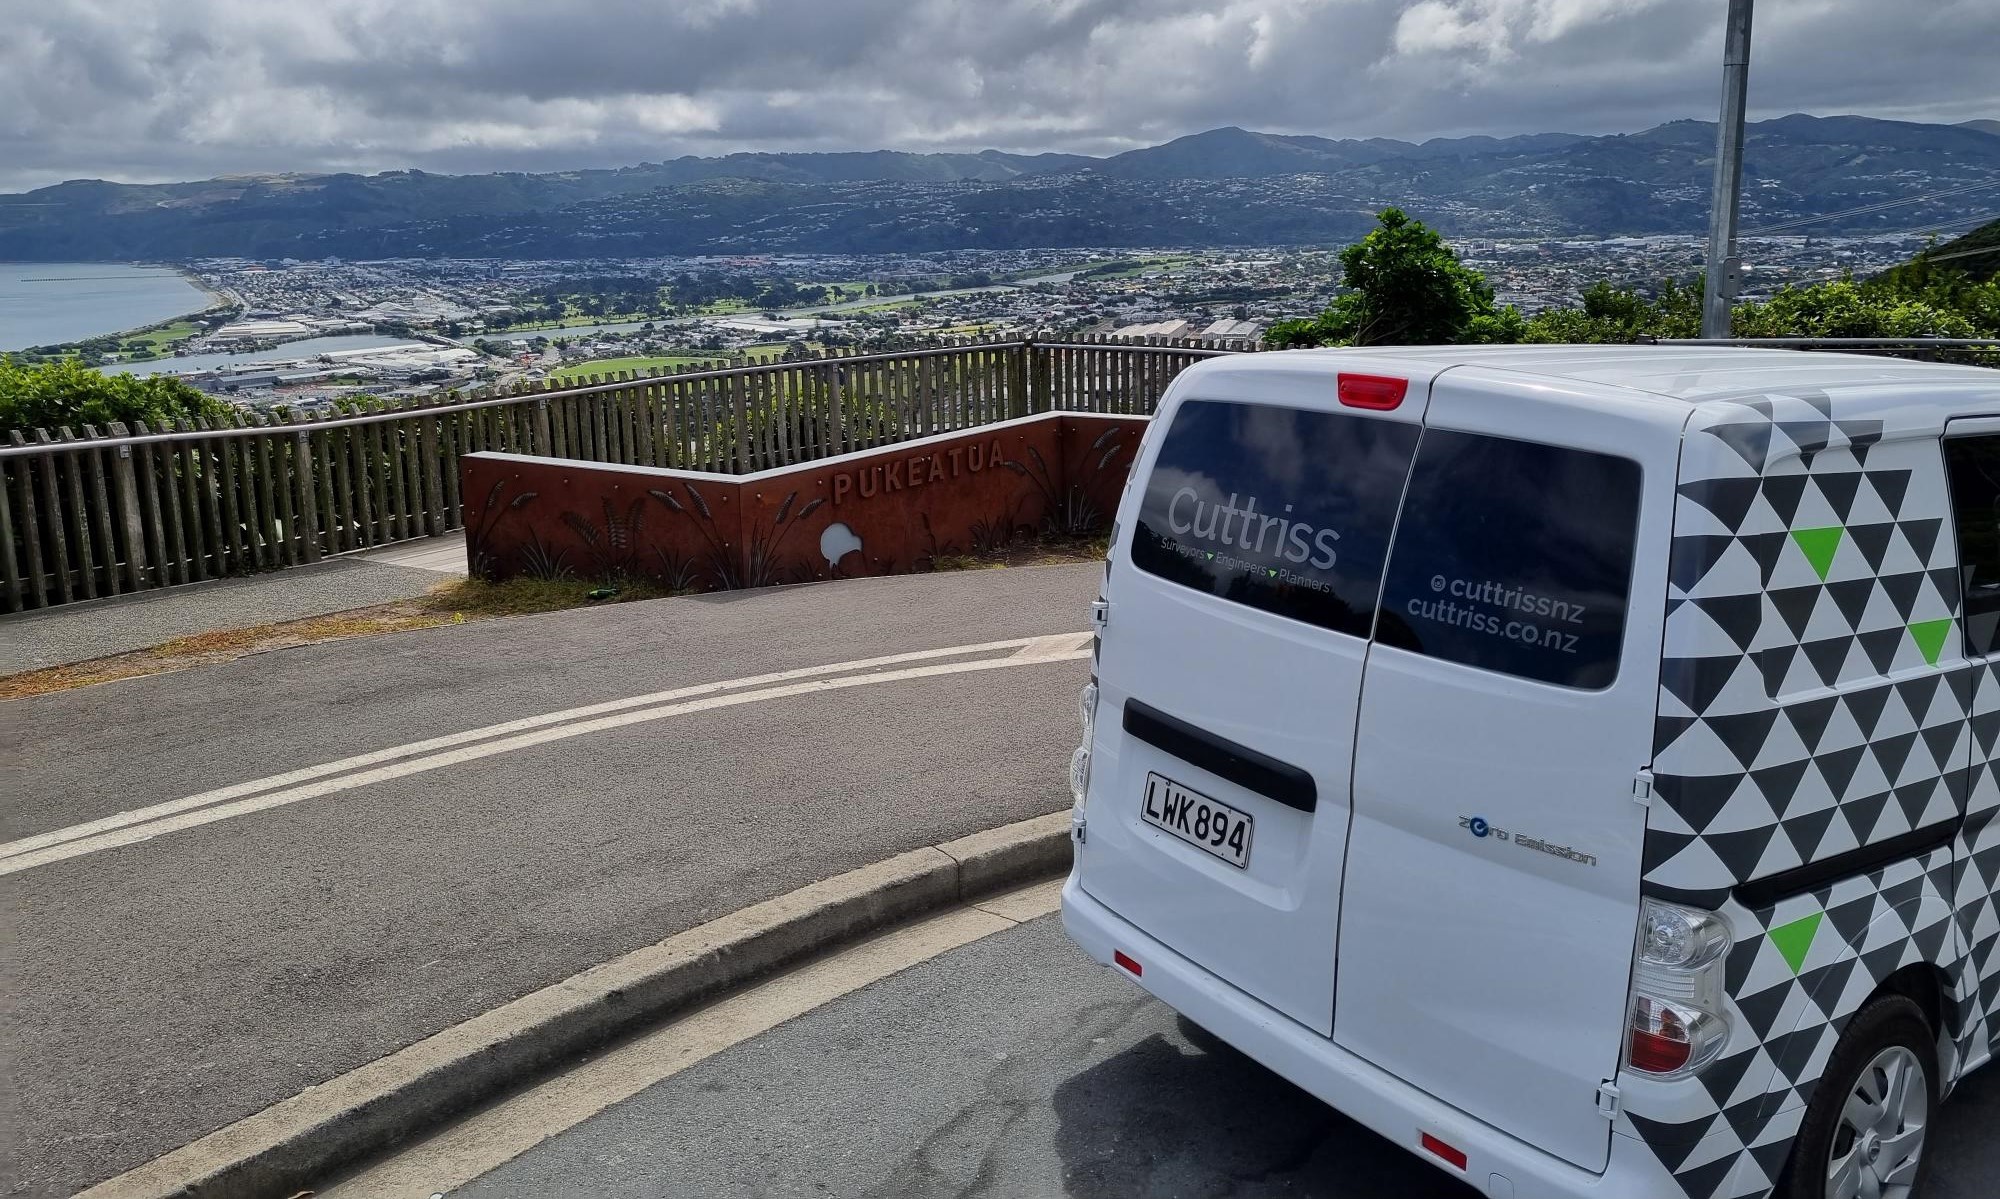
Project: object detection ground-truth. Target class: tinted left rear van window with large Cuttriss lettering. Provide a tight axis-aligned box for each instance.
[1132,400,1418,637]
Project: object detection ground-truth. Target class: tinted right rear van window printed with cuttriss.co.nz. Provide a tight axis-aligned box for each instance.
[1376,430,1640,689]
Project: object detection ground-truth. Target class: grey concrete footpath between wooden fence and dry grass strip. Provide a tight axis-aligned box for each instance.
[0,534,466,673]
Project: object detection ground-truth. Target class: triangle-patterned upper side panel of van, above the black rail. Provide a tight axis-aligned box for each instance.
[1646,411,1972,907]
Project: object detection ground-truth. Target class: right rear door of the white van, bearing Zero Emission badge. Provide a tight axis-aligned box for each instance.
[1334,368,1688,1171]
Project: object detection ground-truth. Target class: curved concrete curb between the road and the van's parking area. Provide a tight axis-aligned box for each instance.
[78,811,1070,1199]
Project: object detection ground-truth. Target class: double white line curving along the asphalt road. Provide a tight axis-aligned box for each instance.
[0,633,1090,875]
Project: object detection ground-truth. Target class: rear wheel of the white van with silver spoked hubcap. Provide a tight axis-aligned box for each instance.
[1778,995,1938,1199]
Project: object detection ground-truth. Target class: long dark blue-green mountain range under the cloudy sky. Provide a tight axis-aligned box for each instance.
[0,114,2000,262]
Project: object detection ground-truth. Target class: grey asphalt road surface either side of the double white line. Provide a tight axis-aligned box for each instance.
[0,566,1100,1195]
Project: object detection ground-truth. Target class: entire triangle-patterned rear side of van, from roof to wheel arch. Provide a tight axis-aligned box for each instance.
[1616,392,1992,1199]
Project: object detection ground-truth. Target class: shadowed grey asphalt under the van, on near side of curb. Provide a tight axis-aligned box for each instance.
[452,917,2000,1199]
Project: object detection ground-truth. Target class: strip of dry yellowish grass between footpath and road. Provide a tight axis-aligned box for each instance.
[0,580,670,699]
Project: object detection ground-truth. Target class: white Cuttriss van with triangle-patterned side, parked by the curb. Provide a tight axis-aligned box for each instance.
[1062,346,2000,1199]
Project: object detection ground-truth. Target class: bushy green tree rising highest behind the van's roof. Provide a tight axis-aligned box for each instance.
[1264,208,1524,348]
